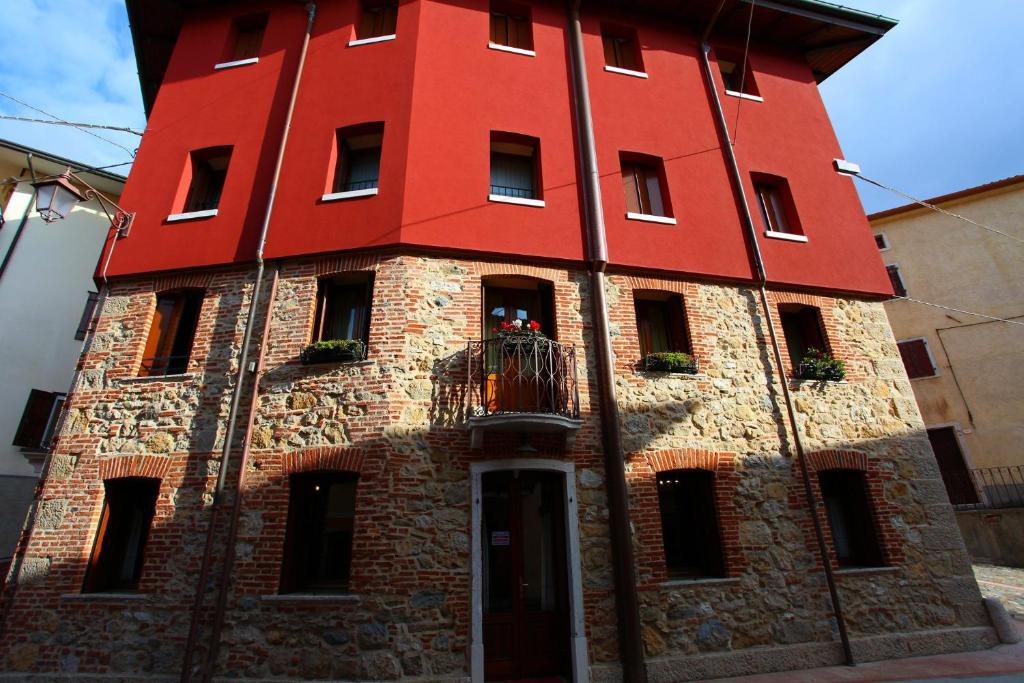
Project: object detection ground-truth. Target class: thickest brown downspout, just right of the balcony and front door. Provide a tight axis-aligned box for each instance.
[568,0,647,683]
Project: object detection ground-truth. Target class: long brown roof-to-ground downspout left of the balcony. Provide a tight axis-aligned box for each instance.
[180,2,316,683]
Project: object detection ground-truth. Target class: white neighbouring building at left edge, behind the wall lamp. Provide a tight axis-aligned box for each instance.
[0,140,125,573]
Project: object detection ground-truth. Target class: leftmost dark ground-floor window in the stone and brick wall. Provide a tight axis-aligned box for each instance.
[84,477,160,593]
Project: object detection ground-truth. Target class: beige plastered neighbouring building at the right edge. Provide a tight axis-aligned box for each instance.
[868,175,1024,507]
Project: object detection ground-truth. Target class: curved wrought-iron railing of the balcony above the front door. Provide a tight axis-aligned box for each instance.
[467,338,580,420]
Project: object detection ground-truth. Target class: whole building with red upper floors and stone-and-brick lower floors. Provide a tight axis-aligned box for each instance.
[2,0,994,681]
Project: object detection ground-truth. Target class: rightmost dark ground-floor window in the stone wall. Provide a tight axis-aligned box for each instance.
[818,470,882,567]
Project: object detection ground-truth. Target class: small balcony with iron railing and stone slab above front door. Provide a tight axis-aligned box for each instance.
[467,338,583,450]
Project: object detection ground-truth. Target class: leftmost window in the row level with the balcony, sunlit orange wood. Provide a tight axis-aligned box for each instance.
[138,291,203,377]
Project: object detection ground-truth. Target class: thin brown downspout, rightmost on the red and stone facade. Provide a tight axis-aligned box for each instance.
[700,30,856,667]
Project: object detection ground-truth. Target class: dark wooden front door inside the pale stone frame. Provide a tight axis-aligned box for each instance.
[480,470,569,681]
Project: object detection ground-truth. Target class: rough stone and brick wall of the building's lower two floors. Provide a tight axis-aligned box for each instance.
[0,255,994,680]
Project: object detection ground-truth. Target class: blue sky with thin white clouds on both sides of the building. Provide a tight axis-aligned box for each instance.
[0,0,1024,213]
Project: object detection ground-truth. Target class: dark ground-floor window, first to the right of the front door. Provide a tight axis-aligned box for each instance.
[657,470,724,578]
